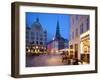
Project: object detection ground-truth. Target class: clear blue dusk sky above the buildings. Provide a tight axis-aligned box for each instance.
[26,12,70,40]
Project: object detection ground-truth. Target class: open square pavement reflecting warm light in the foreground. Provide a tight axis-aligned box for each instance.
[26,54,65,67]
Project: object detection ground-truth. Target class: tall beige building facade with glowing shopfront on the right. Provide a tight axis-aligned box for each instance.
[69,15,90,63]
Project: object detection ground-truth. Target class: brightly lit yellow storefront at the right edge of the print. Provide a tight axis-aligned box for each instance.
[81,31,90,63]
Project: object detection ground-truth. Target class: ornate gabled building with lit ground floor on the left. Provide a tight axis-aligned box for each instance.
[26,18,47,54]
